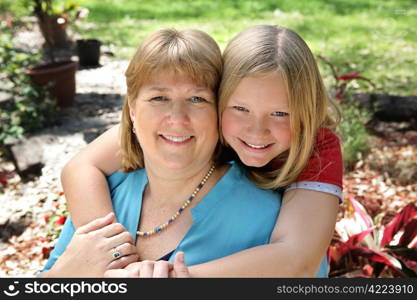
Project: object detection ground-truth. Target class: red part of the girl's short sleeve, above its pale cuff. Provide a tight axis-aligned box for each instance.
[296,128,343,188]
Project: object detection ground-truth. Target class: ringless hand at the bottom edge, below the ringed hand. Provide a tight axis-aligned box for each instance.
[104,252,190,278]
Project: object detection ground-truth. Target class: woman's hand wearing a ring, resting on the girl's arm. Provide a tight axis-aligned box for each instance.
[49,213,139,277]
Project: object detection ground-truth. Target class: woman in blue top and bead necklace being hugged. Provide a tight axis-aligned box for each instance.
[42,30,286,277]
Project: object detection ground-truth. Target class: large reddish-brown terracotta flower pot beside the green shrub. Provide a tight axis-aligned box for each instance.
[27,61,78,107]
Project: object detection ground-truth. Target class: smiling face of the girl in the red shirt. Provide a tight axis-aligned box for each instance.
[222,73,290,167]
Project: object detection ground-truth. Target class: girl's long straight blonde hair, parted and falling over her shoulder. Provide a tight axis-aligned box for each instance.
[219,25,337,189]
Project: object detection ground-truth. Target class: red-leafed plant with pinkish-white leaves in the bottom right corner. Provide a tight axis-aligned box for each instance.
[327,198,417,277]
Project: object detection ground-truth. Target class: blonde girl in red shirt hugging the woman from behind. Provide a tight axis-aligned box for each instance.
[62,26,343,277]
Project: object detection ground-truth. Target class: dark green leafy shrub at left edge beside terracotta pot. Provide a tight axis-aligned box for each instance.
[0,25,57,146]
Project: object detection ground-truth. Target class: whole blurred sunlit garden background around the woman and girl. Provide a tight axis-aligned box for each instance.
[0,0,417,277]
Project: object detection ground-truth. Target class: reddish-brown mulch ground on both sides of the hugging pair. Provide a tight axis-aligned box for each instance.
[0,118,417,277]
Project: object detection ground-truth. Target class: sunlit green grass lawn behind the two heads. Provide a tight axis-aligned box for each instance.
[4,0,417,95]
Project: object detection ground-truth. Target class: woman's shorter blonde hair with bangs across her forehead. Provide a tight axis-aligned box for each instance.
[120,29,222,172]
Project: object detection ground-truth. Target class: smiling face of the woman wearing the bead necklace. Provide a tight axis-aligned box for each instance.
[130,71,218,170]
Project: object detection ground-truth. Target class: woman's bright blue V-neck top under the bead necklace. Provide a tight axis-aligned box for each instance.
[42,163,328,277]
